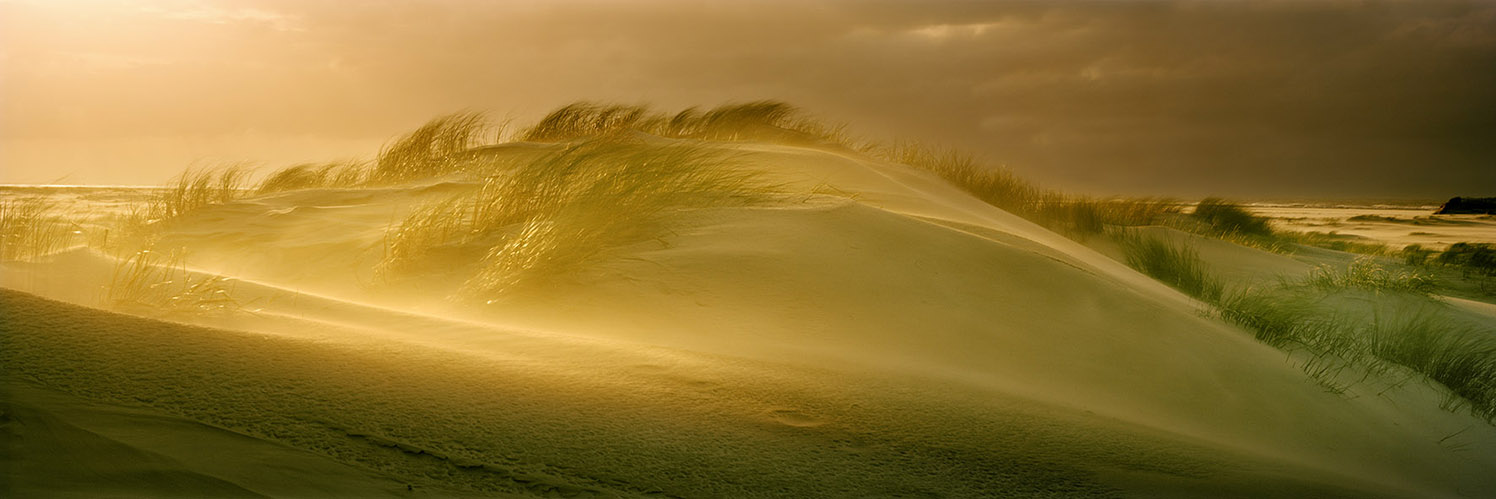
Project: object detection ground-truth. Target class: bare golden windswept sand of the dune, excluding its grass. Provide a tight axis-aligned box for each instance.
[0,139,1496,498]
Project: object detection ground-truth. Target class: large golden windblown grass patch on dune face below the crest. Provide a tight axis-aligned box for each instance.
[377,137,776,300]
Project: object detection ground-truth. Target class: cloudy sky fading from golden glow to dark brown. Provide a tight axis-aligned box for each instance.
[0,0,1496,200]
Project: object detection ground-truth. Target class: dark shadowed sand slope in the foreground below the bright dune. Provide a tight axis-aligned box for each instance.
[0,291,1454,498]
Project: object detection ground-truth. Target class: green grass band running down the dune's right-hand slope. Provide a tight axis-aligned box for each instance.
[1119,235,1496,421]
